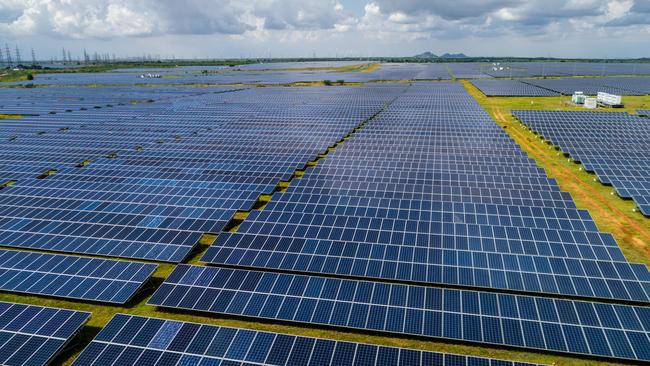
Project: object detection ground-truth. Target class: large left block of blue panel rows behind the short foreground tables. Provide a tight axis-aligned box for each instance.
[0,87,395,262]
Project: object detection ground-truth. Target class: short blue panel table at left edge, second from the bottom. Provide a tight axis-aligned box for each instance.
[0,250,158,304]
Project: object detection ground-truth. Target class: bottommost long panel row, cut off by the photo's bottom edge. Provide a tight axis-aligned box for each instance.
[74,314,540,366]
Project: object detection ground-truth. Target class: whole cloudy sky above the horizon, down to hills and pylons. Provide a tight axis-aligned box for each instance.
[0,0,650,59]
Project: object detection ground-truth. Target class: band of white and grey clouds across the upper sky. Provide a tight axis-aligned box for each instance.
[0,0,650,54]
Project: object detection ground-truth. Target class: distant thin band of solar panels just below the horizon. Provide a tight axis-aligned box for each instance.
[5,60,650,87]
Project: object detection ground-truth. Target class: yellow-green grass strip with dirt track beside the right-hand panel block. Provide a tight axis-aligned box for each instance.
[462,81,650,265]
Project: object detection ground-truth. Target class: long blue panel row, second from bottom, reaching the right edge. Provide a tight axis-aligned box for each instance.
[149,265,650,361]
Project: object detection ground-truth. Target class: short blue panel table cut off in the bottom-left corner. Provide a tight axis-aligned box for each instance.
[0,302,90,365]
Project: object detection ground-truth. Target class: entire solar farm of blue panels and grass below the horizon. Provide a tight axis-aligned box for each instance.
[0,62,650,366]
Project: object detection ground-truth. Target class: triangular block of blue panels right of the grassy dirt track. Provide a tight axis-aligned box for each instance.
[513,110,650,216]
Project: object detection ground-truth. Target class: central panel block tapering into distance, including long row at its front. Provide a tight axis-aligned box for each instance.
[125,83,650,360]
